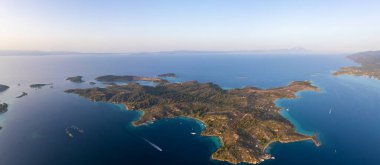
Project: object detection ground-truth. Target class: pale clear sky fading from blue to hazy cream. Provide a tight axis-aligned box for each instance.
[0,0,380,52]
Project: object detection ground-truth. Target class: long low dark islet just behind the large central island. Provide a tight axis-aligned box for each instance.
[95,75,167,83]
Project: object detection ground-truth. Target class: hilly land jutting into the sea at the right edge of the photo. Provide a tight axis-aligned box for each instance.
[333,51,380,79]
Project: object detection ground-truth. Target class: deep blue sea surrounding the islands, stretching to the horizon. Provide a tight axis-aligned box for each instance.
[0,54,380,165]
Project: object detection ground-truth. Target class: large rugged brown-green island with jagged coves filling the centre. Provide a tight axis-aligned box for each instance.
[65,75,320,164]
